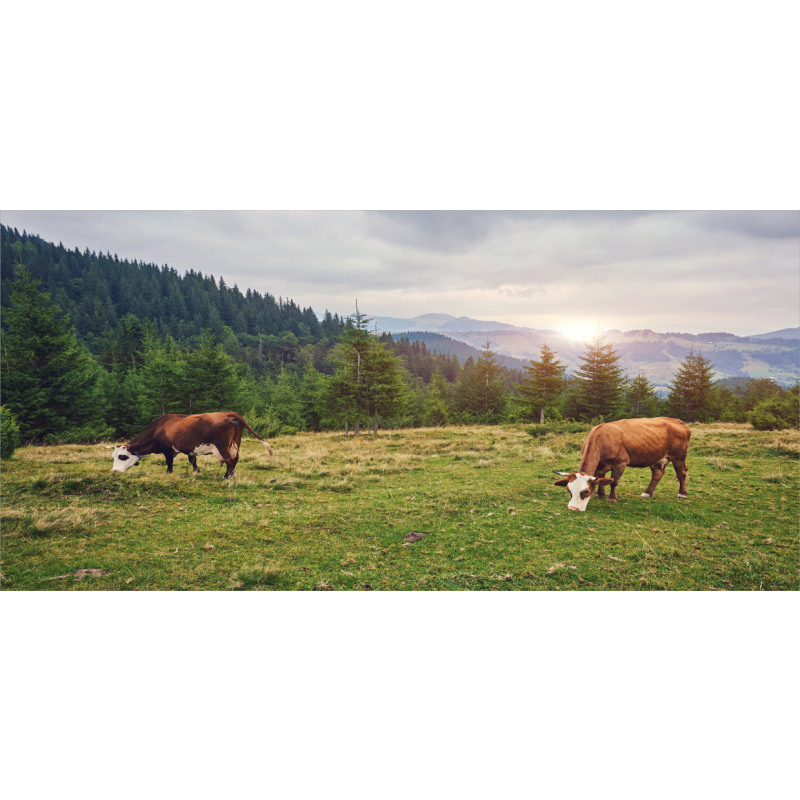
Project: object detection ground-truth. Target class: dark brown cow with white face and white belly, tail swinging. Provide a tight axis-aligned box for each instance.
[111,411,272,478]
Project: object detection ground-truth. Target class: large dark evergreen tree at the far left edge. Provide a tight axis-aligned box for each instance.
[2,264,109,441]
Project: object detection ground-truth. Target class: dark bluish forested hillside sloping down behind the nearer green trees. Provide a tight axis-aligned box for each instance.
[0,225,344,366]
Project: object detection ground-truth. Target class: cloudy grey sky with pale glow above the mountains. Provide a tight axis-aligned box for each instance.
[0,210,800,338]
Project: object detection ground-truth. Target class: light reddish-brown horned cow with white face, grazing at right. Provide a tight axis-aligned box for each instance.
[554,417,691,511]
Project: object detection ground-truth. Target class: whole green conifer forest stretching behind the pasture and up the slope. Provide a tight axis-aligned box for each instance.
[0,226,798,457]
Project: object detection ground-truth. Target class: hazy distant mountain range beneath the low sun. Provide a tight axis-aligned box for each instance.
[380,314,800,392]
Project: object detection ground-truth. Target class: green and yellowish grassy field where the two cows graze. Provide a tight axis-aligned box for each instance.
[1,424,800,591]
